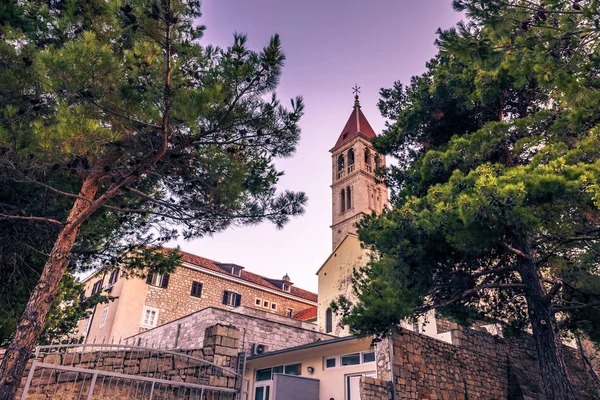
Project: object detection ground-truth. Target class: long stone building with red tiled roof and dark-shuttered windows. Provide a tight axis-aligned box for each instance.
[79,252,317,343]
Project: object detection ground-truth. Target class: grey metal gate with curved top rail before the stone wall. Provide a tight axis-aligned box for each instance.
[21,344,244,400]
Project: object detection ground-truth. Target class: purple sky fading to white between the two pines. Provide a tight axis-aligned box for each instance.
[173,0,461,291]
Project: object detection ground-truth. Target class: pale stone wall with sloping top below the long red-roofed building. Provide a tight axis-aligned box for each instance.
[125,307,333,351]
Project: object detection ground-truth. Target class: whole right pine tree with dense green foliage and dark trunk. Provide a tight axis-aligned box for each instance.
[337,0,600,399]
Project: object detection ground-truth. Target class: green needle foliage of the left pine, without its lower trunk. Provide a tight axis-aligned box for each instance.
[0,0,307,341]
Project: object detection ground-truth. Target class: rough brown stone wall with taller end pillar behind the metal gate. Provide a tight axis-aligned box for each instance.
[17,324,242,400]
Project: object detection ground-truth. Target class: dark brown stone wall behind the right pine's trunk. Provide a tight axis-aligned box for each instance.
[386,328,600,400]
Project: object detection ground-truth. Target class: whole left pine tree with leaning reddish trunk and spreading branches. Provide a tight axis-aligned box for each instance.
[0,0,306,398]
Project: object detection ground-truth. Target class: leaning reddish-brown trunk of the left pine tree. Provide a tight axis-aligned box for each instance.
[0,177,99,400]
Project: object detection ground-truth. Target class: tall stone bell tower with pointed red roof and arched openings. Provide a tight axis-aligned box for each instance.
[330,93,388,249]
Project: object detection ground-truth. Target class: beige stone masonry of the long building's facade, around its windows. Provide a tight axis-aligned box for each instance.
[146,267,312,325]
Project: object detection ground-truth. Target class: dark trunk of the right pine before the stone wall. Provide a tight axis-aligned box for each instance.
[519,252,577,400]
